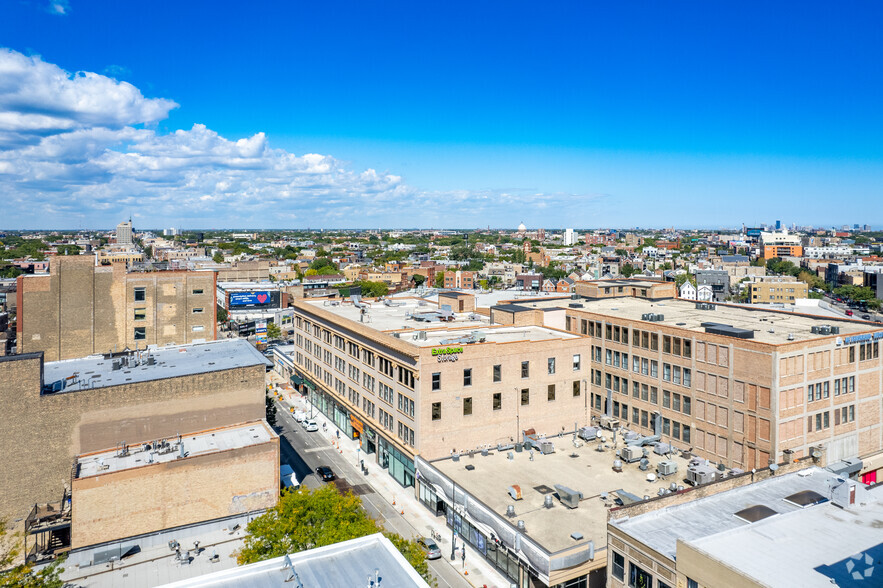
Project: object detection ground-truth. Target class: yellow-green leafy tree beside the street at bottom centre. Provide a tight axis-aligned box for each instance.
[237,485,432,582]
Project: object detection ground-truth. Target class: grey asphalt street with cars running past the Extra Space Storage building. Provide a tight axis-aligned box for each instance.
[276,402,472,588]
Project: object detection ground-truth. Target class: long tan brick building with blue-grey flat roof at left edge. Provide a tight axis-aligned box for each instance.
[0,340,270,536]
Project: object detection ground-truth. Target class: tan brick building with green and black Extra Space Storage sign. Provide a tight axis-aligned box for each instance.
[293,299,589,486]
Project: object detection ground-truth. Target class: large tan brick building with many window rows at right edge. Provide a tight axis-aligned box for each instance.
[565,294,883,469]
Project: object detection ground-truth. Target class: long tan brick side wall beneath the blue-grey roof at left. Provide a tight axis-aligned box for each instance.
[0,354,265,519]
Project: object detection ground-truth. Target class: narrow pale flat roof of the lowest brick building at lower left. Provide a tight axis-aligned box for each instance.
[76,422,276,479]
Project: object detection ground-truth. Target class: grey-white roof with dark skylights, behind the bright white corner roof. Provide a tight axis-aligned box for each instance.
[611,466,840,564]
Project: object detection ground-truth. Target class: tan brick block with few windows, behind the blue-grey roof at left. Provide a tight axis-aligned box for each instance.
[17,256,217,361]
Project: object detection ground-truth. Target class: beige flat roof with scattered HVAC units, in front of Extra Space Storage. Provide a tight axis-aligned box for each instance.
[432,431,688,553]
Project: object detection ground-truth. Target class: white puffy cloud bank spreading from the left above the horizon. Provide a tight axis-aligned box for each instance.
[0,48,601,228]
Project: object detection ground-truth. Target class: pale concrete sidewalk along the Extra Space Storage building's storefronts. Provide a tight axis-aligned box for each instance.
[280,390,512,588]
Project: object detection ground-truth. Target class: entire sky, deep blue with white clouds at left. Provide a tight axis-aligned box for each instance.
[0,0,883,228]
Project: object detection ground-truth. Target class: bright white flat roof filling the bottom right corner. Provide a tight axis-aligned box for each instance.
[689,486,883,588]
